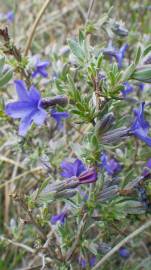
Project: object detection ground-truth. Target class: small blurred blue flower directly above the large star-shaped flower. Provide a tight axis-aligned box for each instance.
[30,55,50,78]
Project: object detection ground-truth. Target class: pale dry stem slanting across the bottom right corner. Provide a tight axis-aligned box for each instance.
[91,220,151,270]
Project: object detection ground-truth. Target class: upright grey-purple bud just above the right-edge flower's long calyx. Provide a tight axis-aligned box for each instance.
[95,113,115,137]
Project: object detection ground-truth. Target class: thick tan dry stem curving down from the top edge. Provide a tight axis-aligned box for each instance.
[24,0,51,56]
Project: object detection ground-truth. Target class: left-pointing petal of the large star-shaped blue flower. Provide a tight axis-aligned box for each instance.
[5,101,33,119]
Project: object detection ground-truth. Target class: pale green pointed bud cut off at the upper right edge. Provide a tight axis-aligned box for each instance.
[131,65,151,83]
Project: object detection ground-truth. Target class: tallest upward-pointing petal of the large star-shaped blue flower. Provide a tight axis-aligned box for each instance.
[14,80,29,101]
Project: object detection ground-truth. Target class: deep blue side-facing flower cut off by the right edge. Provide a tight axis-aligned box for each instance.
[130,102,151,147]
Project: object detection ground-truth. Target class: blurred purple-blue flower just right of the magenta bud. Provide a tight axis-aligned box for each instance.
[100,153,121,175]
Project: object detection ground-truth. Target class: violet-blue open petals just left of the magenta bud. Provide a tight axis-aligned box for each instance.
[61,159,86,178]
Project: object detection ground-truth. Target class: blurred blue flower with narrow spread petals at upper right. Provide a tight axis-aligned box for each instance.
[103,41,128,68]
